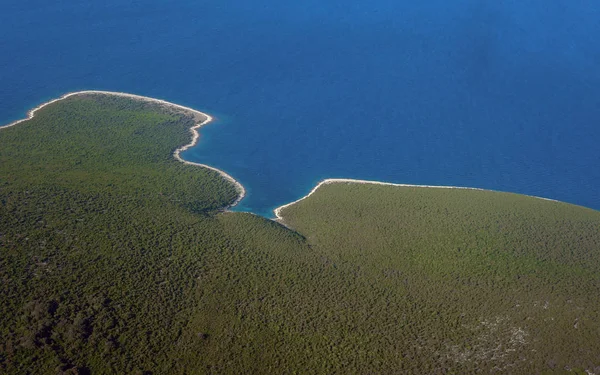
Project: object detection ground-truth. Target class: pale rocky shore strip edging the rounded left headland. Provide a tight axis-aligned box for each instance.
[0,90,246,208]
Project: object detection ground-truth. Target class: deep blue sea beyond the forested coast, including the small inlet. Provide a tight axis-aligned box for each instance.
[0,0,600,215]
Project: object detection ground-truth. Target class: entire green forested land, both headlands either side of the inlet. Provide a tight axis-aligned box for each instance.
[0,95,600,374]
